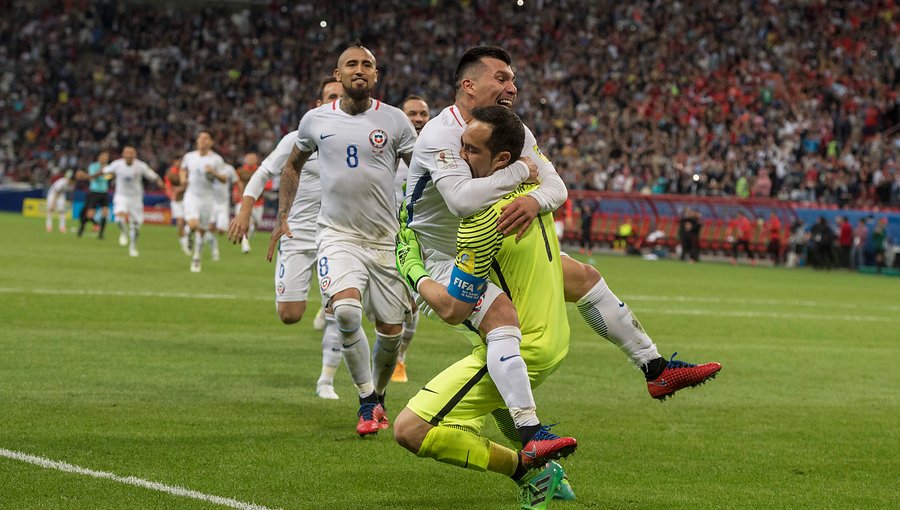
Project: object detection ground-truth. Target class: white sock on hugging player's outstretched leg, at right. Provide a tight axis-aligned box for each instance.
[575,278,660,367]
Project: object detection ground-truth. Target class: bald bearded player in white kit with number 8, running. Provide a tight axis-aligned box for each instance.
[269,44,416,436]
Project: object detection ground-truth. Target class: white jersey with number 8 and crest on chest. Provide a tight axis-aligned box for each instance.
[297,99,416,249]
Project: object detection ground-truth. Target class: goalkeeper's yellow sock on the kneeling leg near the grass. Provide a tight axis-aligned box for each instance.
[418,426,519,476]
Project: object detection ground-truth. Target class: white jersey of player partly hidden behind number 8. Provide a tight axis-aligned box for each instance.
[244,131,322,250]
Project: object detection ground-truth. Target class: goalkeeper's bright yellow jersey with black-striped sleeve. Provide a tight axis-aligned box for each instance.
[451,184,569,371]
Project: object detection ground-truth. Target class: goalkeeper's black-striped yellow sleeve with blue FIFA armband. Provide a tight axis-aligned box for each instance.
[447,207,503,303]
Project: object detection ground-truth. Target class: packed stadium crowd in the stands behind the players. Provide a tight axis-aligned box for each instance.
[0,0,900,207]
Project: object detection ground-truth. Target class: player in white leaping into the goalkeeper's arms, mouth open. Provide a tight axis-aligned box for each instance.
[407,47,721,422]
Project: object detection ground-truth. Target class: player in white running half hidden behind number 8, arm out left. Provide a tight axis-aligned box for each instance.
[228,76,344,399]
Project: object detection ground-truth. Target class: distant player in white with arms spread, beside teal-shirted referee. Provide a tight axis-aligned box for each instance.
[103,146,165,257]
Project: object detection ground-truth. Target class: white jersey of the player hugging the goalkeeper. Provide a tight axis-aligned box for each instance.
[406,105,566,259]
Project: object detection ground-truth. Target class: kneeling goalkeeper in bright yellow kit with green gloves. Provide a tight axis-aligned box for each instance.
[394,106,577,508]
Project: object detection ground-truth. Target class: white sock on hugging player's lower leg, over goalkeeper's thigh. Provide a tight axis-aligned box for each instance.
[485,326,541,428]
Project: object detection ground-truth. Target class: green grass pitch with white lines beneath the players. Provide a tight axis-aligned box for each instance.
[0,214,900,510]
